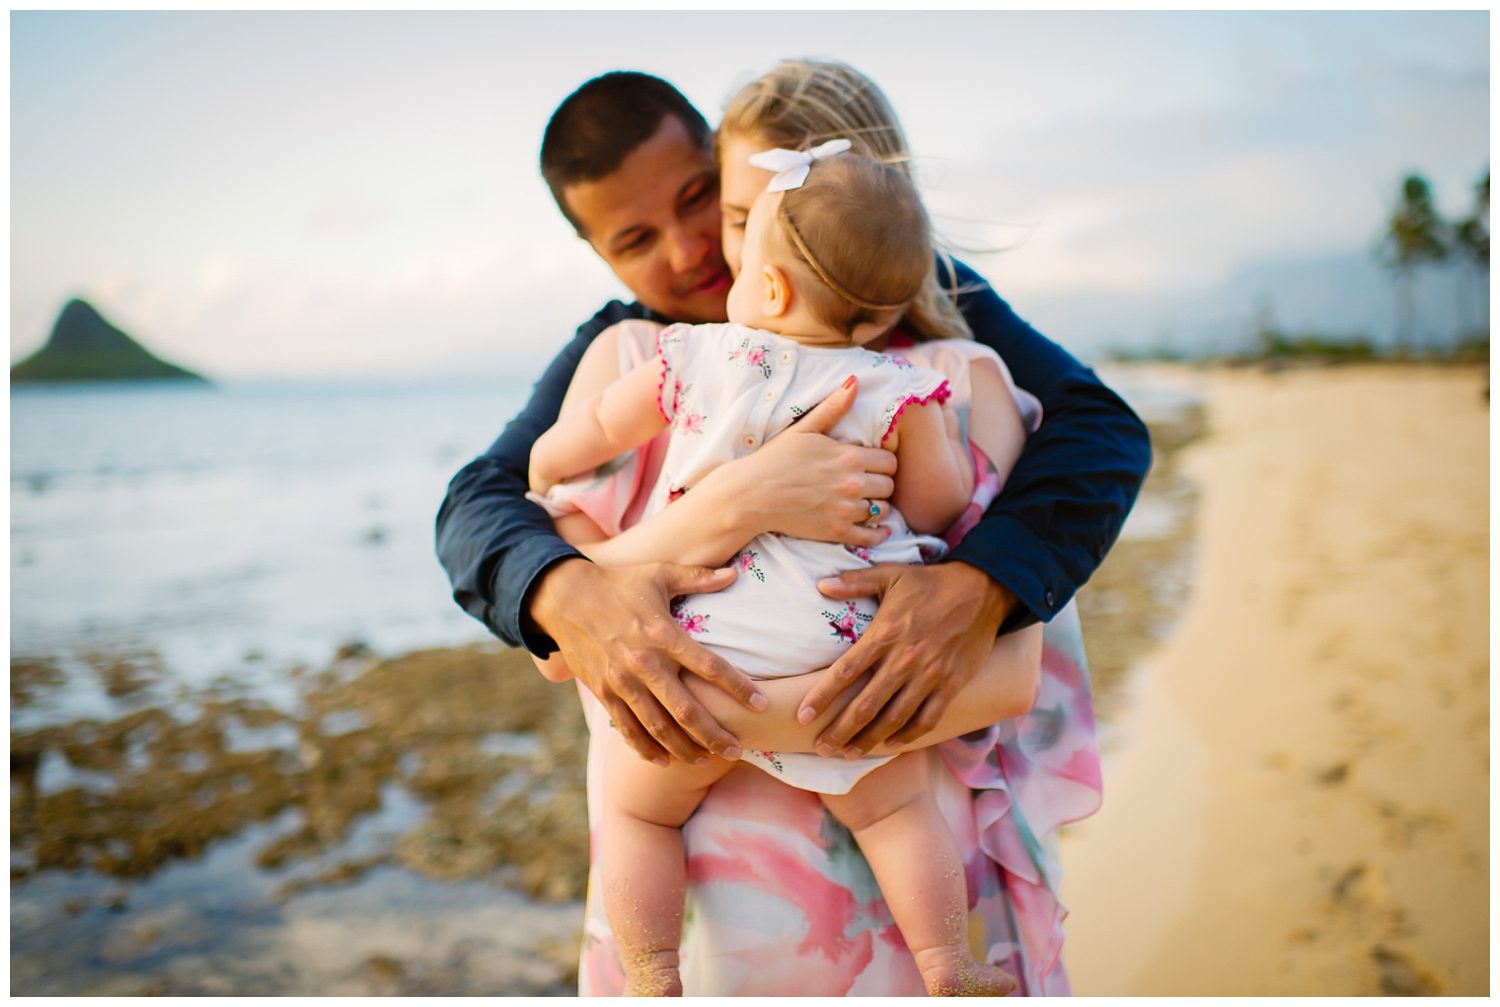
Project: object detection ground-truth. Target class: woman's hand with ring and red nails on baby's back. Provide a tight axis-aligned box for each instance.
[696,377,896,548]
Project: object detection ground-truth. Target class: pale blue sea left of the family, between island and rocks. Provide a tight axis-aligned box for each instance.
[11,383,530,726]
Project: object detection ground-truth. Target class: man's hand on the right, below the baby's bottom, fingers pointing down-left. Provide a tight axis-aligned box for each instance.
[797,563,1016,758]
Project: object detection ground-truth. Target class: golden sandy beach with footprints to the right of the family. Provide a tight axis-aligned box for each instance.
[1062,366,1490,995]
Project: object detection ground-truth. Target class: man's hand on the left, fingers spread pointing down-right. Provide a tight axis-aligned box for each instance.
[531,560,768,765]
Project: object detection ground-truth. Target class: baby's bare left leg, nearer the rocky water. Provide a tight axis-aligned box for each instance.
[599,731,734,996]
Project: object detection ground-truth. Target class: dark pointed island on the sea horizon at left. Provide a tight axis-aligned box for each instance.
[11,299,207,383]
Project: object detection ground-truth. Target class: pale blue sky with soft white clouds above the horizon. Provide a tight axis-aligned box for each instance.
[11,12,1490,377]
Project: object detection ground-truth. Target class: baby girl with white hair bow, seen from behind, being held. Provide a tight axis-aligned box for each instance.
[530,140,1014,995]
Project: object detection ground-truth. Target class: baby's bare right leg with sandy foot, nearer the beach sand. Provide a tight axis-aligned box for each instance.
[822,750,1016,996]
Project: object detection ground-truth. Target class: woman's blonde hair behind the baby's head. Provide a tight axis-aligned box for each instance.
[714,60,974,339]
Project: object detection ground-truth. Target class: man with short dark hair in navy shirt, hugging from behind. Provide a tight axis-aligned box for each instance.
[438,74,1151,761]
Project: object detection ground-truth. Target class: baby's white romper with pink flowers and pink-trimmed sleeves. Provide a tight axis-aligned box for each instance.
[647,324,948,794]
